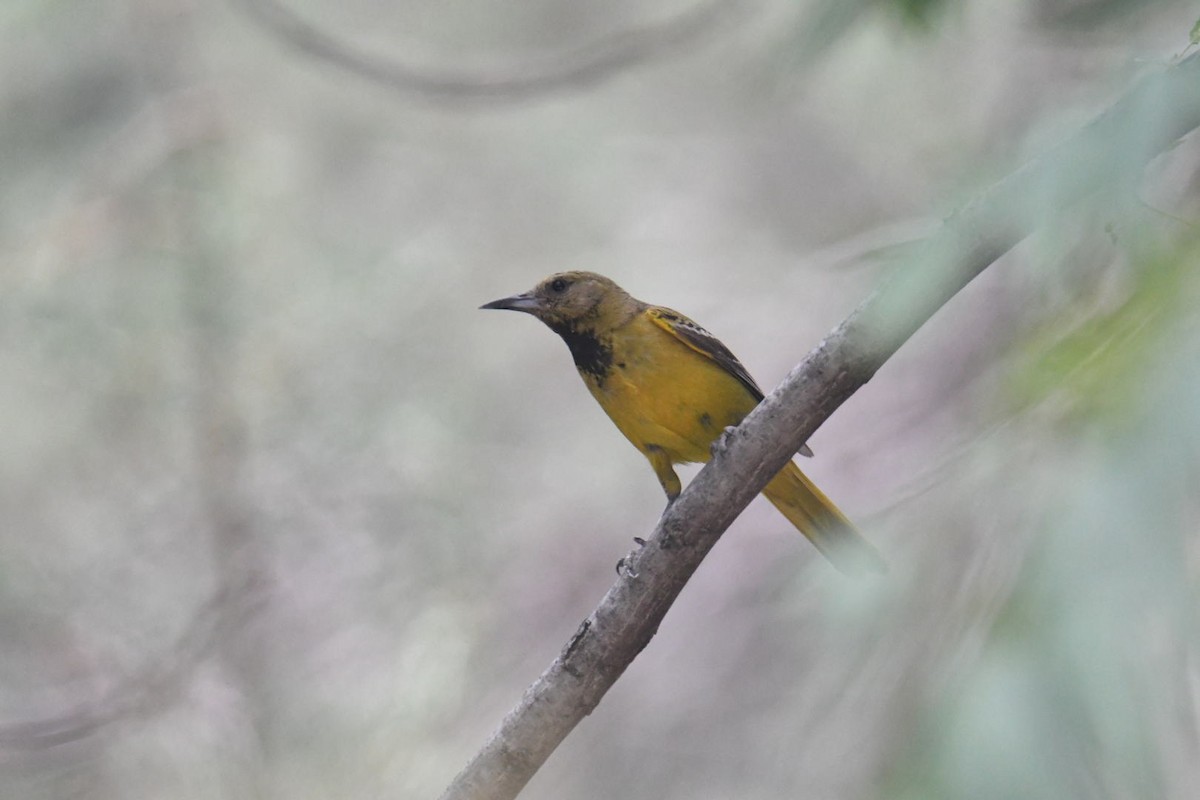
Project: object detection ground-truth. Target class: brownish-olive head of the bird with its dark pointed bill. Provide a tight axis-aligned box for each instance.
[480,272,637,330]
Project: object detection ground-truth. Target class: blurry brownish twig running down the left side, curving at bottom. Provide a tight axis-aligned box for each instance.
[0,4,266,751]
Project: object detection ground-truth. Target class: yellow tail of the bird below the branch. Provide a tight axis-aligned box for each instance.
[762,463,888,575]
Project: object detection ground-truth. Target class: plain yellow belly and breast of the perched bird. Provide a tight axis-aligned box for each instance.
[581,326,757,463]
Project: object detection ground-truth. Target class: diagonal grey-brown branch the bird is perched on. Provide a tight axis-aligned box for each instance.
[442,55,1200,800]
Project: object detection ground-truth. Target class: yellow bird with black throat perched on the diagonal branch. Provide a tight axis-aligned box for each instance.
[480,271,886,575]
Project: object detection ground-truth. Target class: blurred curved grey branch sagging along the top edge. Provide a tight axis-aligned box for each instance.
[231,0,744,102]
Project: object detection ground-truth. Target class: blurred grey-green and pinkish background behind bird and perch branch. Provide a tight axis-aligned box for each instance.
[0,0,1200,800]
